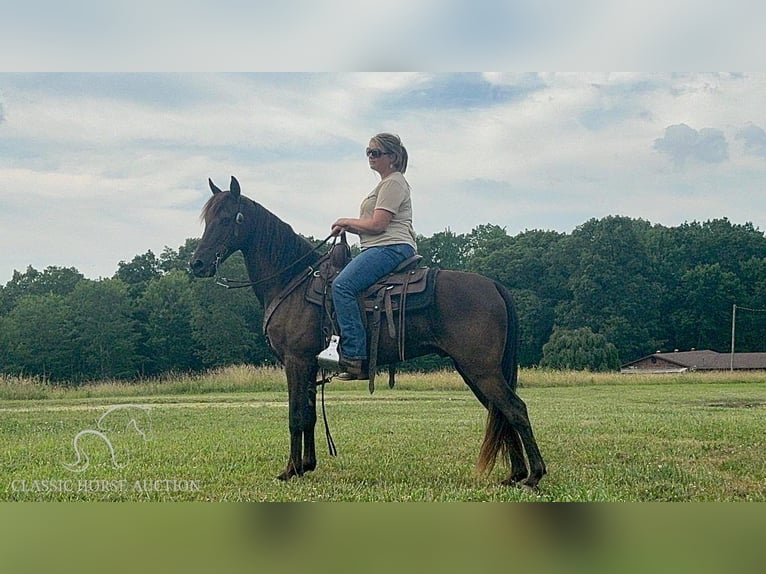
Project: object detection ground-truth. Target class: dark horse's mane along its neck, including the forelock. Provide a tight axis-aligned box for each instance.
[201,192,319,279]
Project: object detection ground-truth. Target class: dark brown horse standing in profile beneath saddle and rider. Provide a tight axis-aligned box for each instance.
[194,176,546,488]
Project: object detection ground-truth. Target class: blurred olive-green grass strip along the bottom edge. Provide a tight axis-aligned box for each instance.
[0,504,764,574]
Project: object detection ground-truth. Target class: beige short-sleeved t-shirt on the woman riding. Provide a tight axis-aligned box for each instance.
[359,171,417,251]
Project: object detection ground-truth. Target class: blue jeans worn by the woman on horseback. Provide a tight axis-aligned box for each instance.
[332,243,415,359]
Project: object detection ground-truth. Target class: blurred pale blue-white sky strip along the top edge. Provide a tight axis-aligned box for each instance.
[0,0,764,71]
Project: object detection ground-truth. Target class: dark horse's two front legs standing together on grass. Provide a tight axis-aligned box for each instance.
[278,358,316,480]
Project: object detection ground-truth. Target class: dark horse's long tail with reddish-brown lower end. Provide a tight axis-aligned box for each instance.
[476,282,519,474]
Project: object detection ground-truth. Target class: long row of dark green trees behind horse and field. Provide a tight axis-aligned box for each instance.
[0,216,766,384]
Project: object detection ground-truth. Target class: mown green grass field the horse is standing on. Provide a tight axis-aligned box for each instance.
[0,367,766,501]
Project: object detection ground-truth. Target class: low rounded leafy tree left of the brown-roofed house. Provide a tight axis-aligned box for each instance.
[540,327,620,371]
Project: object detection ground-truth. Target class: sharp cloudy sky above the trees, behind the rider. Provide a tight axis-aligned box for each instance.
[0,72,766,284]
